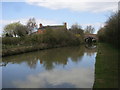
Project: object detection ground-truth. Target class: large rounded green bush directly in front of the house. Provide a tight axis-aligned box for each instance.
[43,29,80,45]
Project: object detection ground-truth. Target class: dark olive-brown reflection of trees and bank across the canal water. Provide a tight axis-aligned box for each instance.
[3,46,95,70]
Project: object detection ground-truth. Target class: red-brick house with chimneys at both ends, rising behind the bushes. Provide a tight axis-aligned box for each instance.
[37,22,67,34]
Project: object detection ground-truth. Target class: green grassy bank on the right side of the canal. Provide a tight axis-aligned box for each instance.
[93,43,120,88]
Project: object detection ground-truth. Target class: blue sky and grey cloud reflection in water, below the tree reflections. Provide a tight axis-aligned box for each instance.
[3,50,96,88]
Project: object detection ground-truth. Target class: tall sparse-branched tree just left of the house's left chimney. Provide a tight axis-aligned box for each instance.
[27,18,37,34]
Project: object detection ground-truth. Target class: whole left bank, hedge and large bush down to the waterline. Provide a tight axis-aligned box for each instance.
[2,30,83,57]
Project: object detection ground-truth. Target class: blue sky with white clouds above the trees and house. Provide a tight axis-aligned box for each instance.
[0,0,118,34]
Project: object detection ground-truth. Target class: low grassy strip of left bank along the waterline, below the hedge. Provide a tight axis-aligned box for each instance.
[2,44,78,57]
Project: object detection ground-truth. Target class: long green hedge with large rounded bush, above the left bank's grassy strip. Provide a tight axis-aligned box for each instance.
[2,29,82,48]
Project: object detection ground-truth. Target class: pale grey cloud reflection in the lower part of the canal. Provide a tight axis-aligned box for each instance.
[12,68,94,88]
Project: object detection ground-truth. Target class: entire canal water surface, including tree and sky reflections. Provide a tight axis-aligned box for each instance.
[1,45,97,88]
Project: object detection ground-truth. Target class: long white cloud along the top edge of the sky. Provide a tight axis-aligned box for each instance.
[26,0,118,12]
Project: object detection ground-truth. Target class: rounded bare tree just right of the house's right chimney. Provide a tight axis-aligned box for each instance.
[70,24,83,35]
